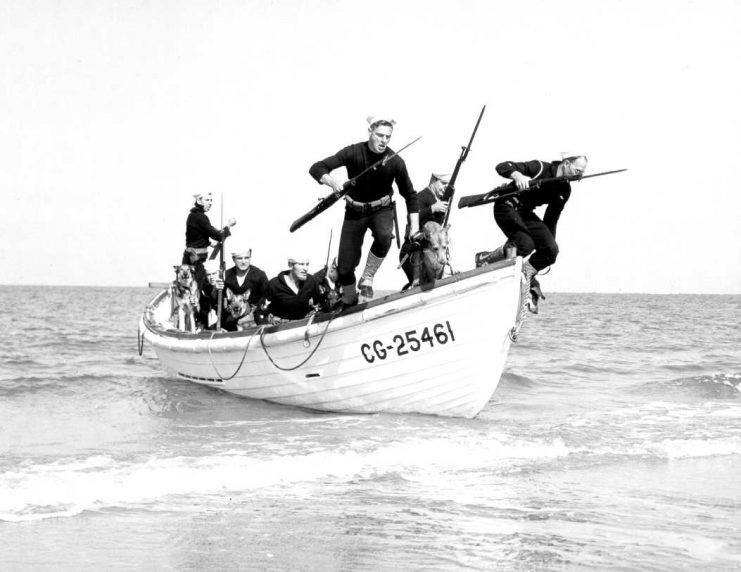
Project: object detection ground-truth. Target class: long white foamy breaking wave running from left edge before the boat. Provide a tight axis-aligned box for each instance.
[0,437,570,521]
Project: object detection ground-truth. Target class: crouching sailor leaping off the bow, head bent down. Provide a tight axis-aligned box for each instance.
[494,152,587,313]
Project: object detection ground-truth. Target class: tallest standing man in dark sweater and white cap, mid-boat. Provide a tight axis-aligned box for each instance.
[309,116,419,306]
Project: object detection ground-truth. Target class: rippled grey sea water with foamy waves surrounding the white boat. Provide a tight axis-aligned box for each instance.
[0,286,741,571]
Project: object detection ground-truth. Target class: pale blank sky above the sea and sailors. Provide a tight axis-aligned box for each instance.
[0,0,741,293]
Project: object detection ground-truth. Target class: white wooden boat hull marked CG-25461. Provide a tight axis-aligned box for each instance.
[140,258,521,417]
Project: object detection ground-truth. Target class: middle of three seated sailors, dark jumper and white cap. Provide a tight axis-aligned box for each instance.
[255,252,321,324]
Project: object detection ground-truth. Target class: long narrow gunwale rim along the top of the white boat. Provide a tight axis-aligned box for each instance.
[142,257,517,341]
